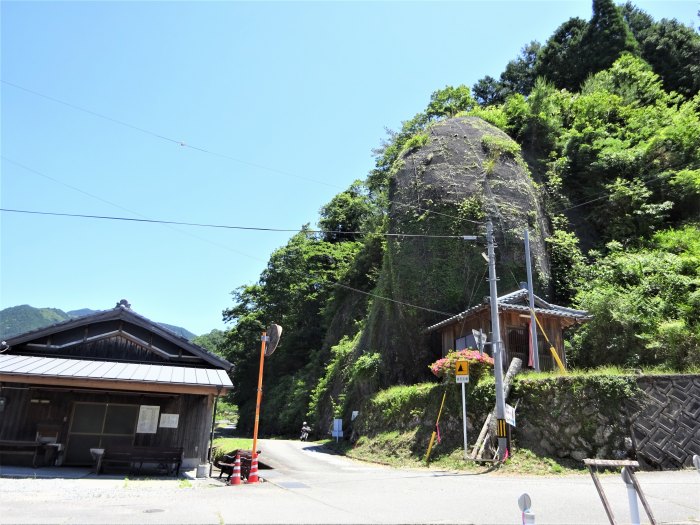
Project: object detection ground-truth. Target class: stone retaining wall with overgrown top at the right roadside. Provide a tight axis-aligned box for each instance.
[508,375,700,469]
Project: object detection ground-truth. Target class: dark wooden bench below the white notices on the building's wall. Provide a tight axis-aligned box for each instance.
[100,447,183,476]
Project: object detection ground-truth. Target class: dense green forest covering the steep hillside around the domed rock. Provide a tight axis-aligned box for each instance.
[202,0,700,433]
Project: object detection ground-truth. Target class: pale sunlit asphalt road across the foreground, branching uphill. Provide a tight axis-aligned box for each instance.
[0,440,700,524]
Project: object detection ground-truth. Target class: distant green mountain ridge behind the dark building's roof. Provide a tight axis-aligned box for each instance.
[0,304,196,341]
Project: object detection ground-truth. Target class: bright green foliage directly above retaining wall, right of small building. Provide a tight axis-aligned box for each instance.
[571,224,700,370]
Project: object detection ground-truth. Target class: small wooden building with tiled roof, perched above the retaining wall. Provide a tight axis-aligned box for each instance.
[425,289,590,370]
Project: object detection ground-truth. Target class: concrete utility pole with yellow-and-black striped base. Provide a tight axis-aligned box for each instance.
[486,220,507,461]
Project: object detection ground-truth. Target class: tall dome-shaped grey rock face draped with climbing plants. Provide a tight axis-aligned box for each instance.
[359,117,549,384]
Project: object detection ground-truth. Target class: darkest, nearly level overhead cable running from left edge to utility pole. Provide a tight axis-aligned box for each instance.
[0,208,474,239]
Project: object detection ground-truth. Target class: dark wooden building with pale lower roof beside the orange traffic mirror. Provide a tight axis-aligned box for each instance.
[0,300,232,468]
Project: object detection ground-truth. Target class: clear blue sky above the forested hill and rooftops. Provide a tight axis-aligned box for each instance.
[0,0,698,334]
